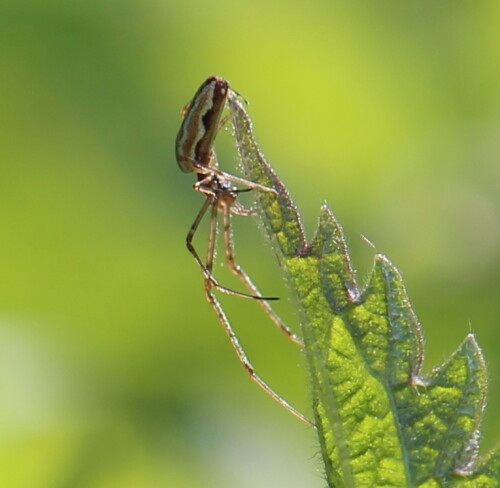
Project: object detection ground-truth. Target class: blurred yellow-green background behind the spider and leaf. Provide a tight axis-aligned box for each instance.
[0,0,500,488]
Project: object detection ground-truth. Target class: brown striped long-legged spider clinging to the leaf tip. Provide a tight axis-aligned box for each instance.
[175,76,311,424]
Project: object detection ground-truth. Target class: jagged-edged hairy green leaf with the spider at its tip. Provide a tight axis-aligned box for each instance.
[230,97,500,488]
